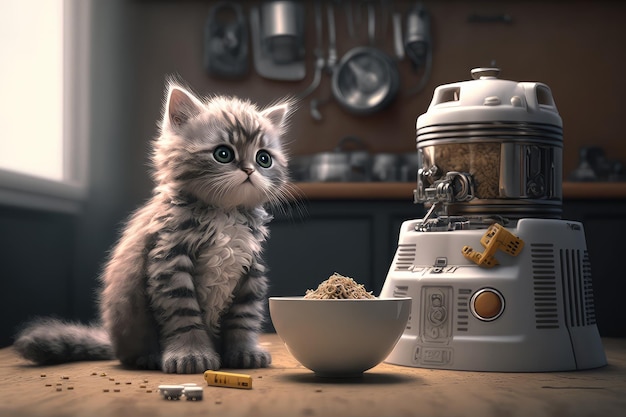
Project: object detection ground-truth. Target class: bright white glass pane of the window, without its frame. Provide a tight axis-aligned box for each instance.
[0,0,64,180]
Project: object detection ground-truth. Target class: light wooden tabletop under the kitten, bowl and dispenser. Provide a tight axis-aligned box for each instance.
[0,334,626,417]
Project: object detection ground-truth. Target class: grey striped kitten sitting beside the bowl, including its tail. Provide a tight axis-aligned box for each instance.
[14,81,290,373]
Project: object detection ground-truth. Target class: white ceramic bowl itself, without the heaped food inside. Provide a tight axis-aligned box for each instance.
[269,297,411,377]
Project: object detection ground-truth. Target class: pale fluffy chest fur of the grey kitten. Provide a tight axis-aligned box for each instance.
[147,196,271,329]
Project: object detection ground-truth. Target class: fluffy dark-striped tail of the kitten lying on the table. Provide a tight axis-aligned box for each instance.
[13,319,115,365]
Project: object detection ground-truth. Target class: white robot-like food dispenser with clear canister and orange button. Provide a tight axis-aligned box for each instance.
[380,68,606,372]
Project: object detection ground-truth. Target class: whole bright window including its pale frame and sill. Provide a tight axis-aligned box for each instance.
[0,0,90,211]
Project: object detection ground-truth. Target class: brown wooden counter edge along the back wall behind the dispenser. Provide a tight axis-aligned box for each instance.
[293,182,626,201]
